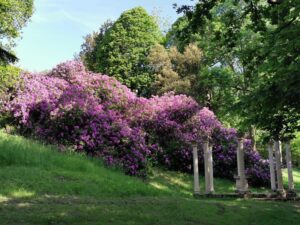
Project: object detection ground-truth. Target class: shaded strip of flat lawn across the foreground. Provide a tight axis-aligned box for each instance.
[0,195,300,225]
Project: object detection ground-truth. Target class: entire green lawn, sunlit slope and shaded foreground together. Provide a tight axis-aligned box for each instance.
[0,132,300,225]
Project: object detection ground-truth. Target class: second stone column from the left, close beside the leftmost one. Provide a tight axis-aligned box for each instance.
[203,140,214,194]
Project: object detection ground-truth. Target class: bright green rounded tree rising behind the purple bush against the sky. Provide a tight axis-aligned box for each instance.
[95,7,162,96]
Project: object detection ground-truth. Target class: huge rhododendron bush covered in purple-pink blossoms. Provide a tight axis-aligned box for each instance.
[5,61,269,185]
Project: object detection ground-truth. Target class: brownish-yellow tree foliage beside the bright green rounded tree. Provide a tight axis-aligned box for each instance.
[148,44,203,95]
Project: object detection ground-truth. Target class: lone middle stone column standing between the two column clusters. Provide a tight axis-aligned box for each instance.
[237,138,248,193]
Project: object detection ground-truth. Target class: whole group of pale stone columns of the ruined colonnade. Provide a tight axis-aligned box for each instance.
[192,138,295,196]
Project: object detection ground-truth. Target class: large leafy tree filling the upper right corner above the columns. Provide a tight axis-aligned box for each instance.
[173,0,300,141]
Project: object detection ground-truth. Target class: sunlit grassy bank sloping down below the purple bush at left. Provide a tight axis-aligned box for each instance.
[0,130,162,197]
